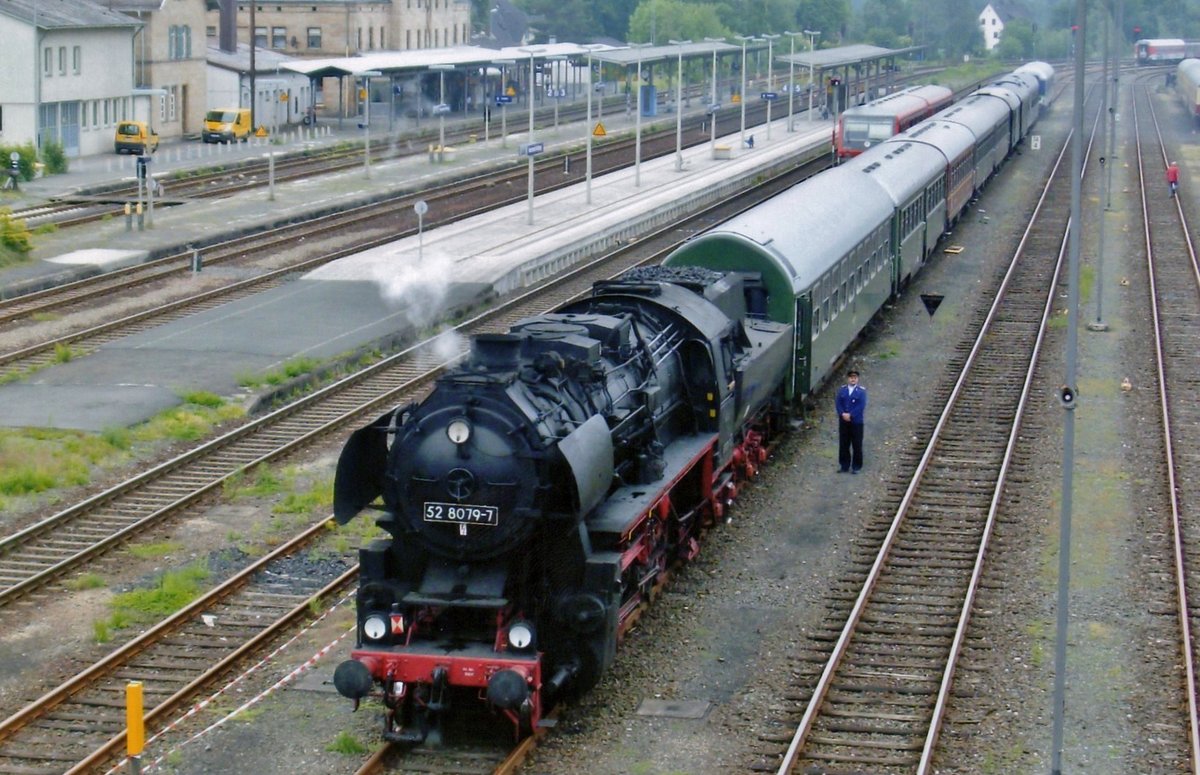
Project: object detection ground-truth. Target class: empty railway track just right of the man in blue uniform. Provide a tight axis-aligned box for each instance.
[760,86,1094,775]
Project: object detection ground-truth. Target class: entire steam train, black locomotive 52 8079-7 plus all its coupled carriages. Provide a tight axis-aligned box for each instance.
[334,62,1054,743]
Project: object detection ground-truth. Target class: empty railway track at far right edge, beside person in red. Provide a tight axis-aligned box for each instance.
[1133,86,1200,773]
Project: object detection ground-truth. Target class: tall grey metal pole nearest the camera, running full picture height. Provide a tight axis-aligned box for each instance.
[1050,0,1087,775]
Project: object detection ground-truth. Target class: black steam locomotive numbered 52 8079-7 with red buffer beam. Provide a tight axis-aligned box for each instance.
[334,266,793,743]
